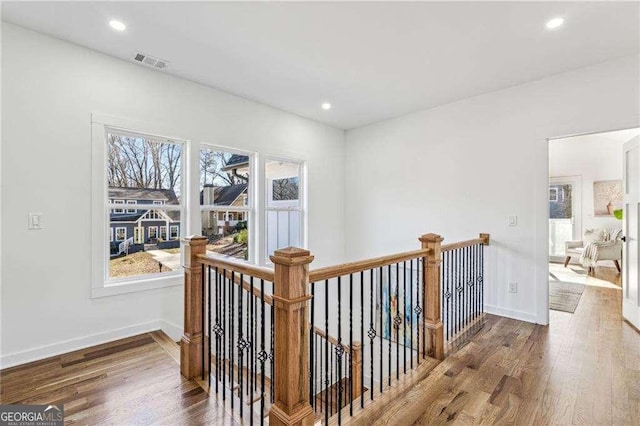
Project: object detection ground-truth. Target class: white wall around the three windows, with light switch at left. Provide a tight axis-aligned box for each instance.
[0,23,344,366]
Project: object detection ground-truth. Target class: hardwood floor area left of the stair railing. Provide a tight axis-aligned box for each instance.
[0,332,239,425]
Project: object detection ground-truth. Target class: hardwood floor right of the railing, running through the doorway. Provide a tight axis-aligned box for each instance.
[364,268,640,425]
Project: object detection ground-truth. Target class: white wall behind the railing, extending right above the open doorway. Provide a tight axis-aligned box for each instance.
[345,56,640,323]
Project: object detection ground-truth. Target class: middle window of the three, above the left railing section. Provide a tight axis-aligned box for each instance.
[199,147,252,261]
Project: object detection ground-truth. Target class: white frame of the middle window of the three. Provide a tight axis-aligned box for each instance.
[199,143,262,264]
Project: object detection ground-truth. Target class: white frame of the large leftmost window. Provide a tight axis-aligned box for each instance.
[91,113,191,298]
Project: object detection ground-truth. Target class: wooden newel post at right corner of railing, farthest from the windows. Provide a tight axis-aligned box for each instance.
[420,234,444,360]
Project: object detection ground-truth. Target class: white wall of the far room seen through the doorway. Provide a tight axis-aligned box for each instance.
[549,132,632,235]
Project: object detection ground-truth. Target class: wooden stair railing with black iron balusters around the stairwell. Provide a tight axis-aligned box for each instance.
[180,234,489,425]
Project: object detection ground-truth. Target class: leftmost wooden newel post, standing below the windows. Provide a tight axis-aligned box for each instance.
[180,236,207,379]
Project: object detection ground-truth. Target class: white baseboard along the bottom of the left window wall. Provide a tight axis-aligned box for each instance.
[0,320,182,370]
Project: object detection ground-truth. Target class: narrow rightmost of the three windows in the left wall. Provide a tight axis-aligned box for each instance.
[265,158,305,263]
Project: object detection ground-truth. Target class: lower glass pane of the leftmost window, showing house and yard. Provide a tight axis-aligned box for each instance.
[108,209,181,279]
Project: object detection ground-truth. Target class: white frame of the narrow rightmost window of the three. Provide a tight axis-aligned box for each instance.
[261,155,308,266]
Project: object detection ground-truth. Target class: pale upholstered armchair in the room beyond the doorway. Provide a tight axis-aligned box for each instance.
[564,229,622,272]
